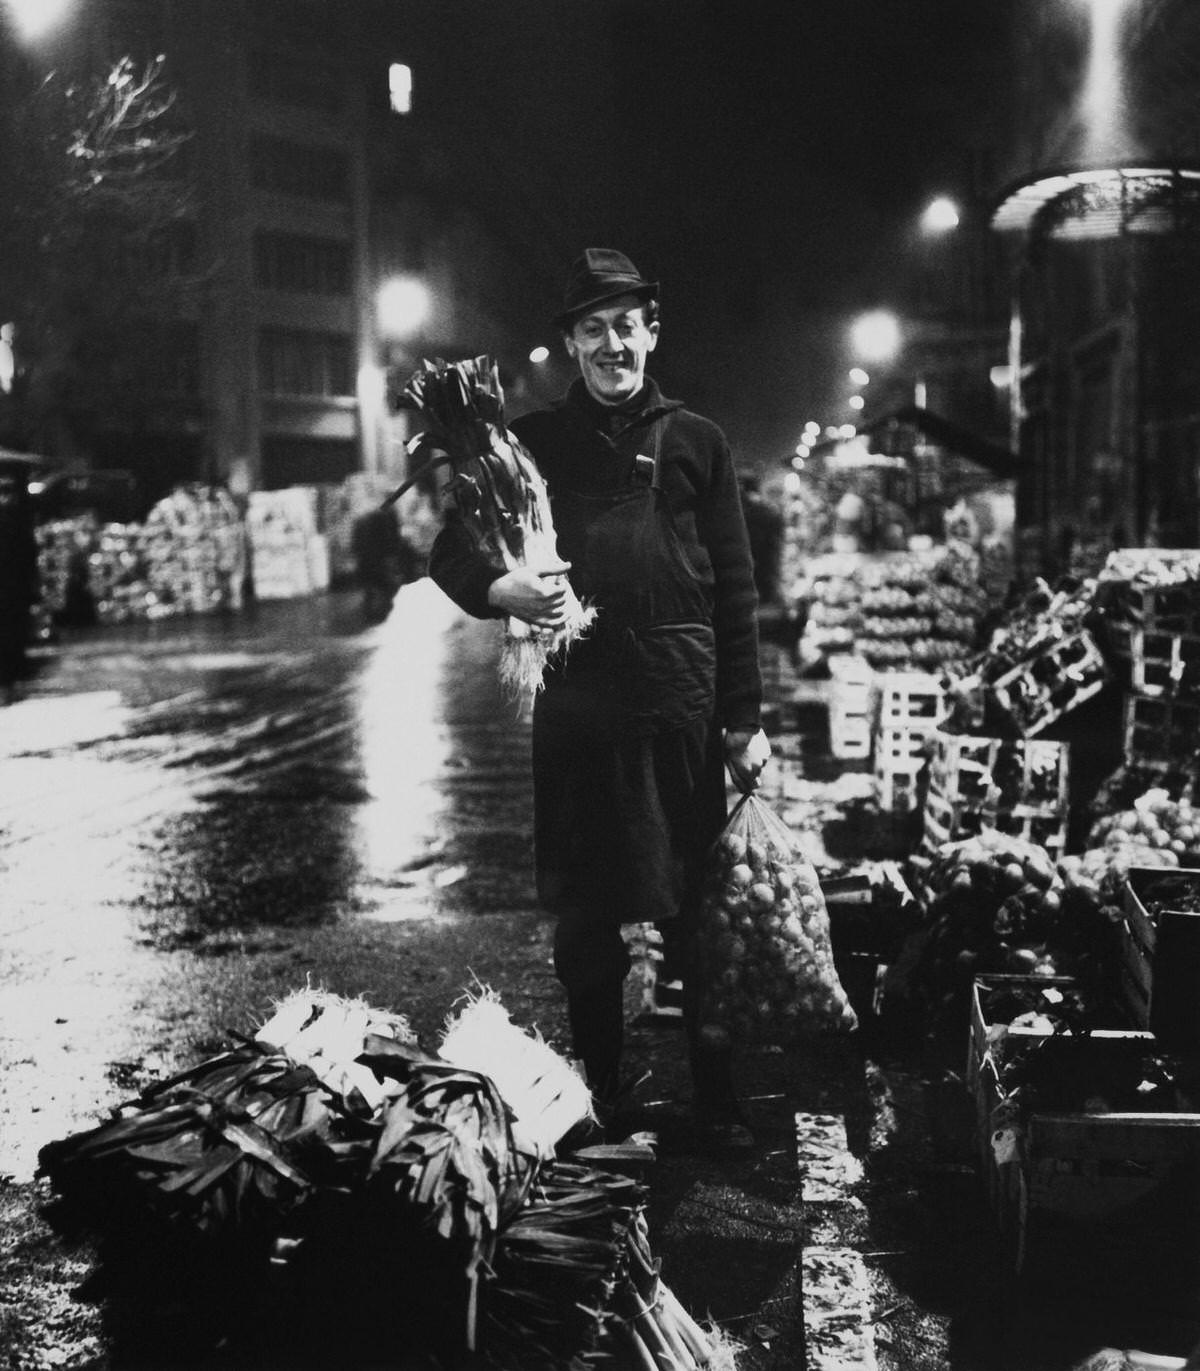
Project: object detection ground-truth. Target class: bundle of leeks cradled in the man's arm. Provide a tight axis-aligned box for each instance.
[392,356,595,696]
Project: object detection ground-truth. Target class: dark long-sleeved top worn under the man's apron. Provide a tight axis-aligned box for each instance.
[429,380,763,729]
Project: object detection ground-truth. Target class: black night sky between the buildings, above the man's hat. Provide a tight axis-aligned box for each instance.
[402,0,1012,462]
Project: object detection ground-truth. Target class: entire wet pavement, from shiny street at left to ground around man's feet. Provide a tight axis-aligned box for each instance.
[0,581,1190,1371]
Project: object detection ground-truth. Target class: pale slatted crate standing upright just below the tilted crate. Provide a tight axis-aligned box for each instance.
[923,729,1070,853]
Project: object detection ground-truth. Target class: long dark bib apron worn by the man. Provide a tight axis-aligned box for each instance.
[533,417,724,984]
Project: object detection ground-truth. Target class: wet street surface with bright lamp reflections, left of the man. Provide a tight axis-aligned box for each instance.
[0,581,553,1178]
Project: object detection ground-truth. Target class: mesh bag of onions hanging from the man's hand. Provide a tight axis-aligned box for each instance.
[697,794,859,1046]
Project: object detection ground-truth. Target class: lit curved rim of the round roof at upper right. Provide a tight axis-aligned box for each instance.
[992,163,1200,240]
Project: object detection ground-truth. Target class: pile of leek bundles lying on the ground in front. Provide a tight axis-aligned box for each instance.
[40,988,734,1371]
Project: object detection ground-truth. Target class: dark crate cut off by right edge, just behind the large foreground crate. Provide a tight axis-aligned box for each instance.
[1116,866,1200,1045]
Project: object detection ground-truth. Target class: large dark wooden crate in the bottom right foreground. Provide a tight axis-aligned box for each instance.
[971,1008,1200,1288]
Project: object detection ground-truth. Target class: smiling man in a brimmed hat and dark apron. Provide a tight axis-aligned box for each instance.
[429,248,769,1146]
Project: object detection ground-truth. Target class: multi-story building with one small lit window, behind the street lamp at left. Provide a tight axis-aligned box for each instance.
[38,0,581,510]
